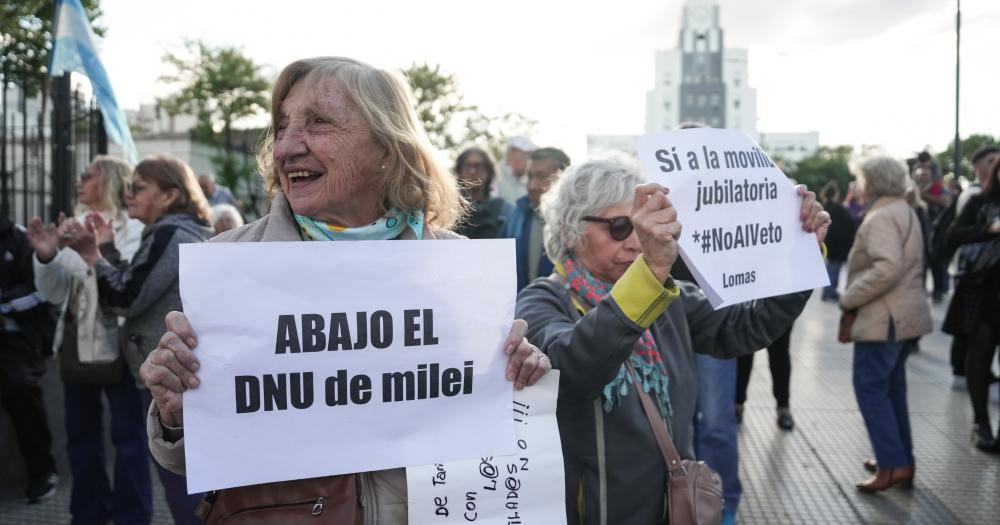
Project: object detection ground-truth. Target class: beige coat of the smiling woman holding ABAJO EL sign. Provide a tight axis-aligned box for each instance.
[146,193,462,525]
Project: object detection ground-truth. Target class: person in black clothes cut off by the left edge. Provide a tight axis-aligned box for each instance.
[0,217,58,503]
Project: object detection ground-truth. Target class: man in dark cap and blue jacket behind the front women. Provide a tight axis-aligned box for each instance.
[499,148,570,292]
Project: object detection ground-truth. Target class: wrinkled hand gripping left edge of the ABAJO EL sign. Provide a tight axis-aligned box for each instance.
[139,312,201,427]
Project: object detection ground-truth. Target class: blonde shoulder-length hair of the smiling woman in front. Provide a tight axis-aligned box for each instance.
[257,57,468,229]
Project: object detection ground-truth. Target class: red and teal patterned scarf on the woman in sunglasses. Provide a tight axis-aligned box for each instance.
[562,254,672,421]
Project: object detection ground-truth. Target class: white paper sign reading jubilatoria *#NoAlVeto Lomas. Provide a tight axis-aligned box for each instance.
[636,128,829,308]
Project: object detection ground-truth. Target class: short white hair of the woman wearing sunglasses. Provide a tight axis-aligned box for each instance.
[540,156,646,262]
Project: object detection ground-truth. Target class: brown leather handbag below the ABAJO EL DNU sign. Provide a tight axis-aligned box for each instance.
[196,474,364,525]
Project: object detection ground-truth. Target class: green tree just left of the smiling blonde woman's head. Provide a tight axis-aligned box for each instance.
[157,42,271,195]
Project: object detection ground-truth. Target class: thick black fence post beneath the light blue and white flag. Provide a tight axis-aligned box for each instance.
[49,73,73,221]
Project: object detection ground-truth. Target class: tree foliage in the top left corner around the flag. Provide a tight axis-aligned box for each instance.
[0,0,104,96]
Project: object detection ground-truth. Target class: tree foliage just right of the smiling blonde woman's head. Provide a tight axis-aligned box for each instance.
[403,63,536,159]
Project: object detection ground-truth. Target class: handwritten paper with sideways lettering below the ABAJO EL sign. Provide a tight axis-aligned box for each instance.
[406,370,566,525]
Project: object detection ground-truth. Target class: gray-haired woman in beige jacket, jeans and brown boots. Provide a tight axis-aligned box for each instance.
[840,157,932,492]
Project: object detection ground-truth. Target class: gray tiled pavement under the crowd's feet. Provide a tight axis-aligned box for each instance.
[0,294,1000,525]
